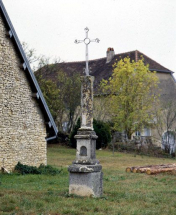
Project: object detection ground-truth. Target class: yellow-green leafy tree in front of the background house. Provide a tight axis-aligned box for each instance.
[100,57,158,139]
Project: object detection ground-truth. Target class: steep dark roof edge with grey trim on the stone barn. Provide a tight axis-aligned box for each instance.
[0,0,58,140]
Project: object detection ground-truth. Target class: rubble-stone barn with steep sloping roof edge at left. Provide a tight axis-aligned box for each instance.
[0,0,58,171]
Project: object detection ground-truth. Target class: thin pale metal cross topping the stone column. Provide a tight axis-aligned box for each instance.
[75,27,100,76]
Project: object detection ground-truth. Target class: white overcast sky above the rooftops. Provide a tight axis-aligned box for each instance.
[3,0,176,72]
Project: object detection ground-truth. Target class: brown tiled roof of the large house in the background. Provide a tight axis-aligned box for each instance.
[37,50,173,92]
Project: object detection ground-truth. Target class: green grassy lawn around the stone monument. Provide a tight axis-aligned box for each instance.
[0,146,176,215]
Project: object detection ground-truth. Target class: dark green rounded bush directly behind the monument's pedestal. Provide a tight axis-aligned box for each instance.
[70,118,111,149]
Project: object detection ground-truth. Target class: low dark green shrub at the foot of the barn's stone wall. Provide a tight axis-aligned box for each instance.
[15,162,61,175]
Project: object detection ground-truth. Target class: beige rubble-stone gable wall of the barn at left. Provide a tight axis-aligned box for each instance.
[0,15,47,170]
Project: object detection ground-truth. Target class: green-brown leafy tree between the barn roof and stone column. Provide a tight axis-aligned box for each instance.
[35,68,81,133]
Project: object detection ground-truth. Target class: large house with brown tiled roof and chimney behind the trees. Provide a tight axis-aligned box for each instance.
[36,48,176,144]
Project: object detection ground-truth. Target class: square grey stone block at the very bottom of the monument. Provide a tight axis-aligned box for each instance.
[69,171,103,197]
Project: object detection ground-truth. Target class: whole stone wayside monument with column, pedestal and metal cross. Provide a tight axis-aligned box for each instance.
[68,28,103,197]
